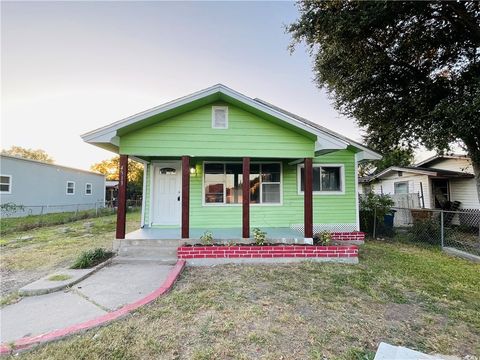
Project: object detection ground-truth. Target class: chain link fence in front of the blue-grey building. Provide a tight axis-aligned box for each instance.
[0,200,142,235]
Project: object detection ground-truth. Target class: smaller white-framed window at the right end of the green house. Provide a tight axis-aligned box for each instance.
[299,164,343,193]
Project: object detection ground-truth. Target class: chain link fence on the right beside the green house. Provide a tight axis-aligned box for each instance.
[360,207,480,256]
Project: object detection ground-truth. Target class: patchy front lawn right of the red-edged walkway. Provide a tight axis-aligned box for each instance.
[12,242,480,360]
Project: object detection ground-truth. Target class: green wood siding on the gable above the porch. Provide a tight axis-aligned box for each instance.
[120,103,315,159]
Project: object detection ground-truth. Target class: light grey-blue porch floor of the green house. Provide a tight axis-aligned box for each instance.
[125,227,304,240]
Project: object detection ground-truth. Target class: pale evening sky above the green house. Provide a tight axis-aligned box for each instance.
[1,2,360,169]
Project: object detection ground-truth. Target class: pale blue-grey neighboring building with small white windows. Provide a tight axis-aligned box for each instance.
[0,155,105,216]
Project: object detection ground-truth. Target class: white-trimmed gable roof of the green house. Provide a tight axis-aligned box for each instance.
[81,84,381,160]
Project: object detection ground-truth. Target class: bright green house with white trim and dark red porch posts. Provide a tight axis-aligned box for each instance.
[82,84,380,239]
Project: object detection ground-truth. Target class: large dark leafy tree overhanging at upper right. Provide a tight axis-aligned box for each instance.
[287,0,480,198]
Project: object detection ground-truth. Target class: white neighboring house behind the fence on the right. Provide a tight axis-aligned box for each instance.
[368,155,480,209]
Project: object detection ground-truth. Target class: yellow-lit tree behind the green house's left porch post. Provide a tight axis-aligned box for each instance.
[90,156,143,199]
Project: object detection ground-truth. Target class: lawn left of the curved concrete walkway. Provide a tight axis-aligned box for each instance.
[0,211,140,296]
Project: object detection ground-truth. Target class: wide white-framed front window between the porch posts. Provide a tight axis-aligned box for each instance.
[204,163,281,204]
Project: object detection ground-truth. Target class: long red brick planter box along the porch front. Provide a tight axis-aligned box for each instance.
[177,245,358,265]
